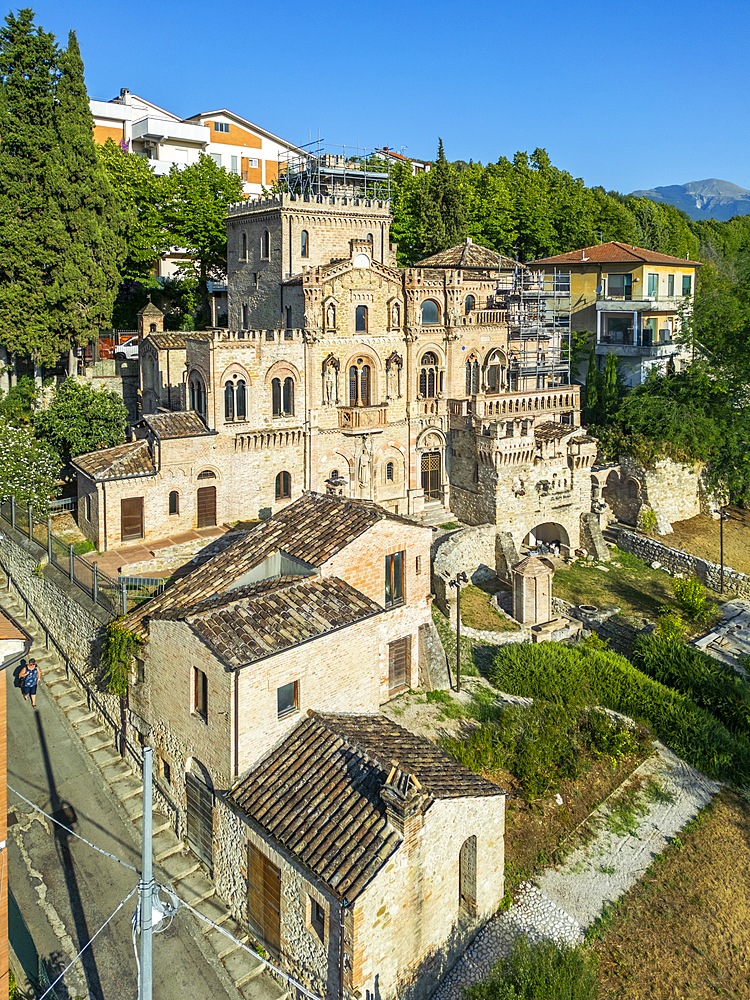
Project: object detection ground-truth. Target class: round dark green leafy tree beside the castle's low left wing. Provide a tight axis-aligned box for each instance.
[34,378,128,463]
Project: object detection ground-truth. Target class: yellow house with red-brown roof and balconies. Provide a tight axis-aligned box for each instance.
[534,243,700,386]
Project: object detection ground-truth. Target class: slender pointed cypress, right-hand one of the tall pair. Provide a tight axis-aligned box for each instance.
[53,31,125,364]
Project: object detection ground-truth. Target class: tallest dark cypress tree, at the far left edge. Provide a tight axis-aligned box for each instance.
[0,9,65,364]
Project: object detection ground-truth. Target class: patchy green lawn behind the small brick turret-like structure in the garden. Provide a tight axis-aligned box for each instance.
[552,549,712,621]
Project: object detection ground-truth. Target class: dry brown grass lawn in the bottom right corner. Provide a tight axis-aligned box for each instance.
[590,792,750,1000]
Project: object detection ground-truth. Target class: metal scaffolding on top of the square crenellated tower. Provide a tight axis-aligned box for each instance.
[279,139,391,201]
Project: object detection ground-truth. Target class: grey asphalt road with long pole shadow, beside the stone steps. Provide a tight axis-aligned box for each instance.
[7,644,235,1000]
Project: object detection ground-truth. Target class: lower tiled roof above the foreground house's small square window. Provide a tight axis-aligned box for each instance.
[179,577,383,667]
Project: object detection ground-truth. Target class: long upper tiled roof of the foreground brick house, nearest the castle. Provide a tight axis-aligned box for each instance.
[128,493,432,633]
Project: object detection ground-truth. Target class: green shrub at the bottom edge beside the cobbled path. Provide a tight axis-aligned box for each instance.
[465,935,599,1000]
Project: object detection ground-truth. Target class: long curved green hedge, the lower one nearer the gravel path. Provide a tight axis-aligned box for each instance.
[489,642,750,784]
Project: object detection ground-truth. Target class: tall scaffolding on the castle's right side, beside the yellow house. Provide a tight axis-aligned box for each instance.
[495,265,571,391]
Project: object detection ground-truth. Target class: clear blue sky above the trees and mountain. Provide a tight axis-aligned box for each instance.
[20,0,750,192]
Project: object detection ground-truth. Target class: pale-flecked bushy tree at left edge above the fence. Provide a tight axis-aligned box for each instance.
[0,417,60,517]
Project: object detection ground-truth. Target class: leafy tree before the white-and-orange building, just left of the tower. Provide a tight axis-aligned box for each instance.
[164,155,242,324]
